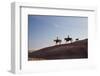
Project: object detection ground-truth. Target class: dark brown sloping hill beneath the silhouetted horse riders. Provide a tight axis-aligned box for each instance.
[28,39,88,60]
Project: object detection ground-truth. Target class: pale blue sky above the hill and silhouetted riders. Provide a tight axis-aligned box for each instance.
[28,15,88,50]
